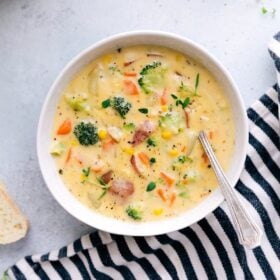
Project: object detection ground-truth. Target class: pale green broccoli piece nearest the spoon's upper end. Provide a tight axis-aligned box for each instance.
[159,112,186,134]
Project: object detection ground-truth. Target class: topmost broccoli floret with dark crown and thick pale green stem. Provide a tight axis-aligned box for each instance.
[138,62,166,94]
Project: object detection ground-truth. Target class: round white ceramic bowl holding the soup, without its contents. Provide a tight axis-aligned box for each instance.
[37,31,248,236]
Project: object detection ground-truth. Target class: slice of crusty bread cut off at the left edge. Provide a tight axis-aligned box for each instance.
[0,182,29,244]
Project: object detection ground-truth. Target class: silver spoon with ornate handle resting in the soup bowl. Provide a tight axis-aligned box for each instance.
[198,131,263,249]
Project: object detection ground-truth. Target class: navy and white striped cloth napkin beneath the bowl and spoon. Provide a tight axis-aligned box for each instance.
[4,33,280,280]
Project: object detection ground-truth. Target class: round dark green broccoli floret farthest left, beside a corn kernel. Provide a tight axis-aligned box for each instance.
[74,122,98,146]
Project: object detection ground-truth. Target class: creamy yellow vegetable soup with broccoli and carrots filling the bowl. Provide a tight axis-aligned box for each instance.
[50,45,234,222]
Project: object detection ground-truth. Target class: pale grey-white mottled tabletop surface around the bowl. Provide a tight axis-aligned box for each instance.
[0,0,280,274]
